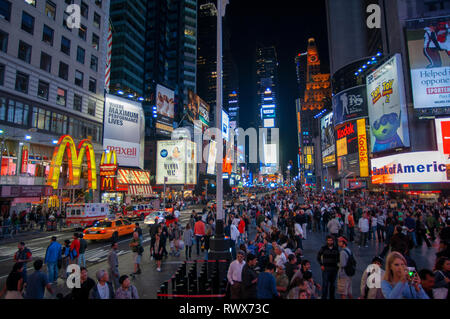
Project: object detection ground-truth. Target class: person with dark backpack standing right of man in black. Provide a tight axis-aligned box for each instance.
[337,236,355,299]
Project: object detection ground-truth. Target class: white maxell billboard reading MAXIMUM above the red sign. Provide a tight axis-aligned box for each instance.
[103,94,145,168]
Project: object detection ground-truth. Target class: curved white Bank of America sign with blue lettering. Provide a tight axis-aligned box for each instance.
[371,151,450,184]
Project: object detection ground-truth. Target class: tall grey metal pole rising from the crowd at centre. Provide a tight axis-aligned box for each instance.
[216,0,224,220]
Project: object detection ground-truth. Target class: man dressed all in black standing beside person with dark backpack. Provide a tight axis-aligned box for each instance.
[317,235,339,299]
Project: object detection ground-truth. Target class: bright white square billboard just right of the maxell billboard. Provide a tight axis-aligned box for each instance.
[156,140,197,185]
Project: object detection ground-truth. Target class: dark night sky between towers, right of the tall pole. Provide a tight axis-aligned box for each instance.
[227,0,329,178]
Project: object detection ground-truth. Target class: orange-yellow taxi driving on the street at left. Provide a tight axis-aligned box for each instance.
[83,219,136,241]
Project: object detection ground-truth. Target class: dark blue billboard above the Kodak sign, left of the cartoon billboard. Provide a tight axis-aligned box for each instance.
[333,85,367,126]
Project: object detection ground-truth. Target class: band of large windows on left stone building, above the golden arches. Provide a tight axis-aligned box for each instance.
[0,96,102,143]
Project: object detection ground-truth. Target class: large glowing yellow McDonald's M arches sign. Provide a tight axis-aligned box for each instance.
[47,135,97,189]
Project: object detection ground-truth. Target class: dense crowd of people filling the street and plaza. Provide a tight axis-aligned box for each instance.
[0,188,450,299]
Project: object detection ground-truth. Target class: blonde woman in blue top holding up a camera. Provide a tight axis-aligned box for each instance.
[381,252,430,299]
